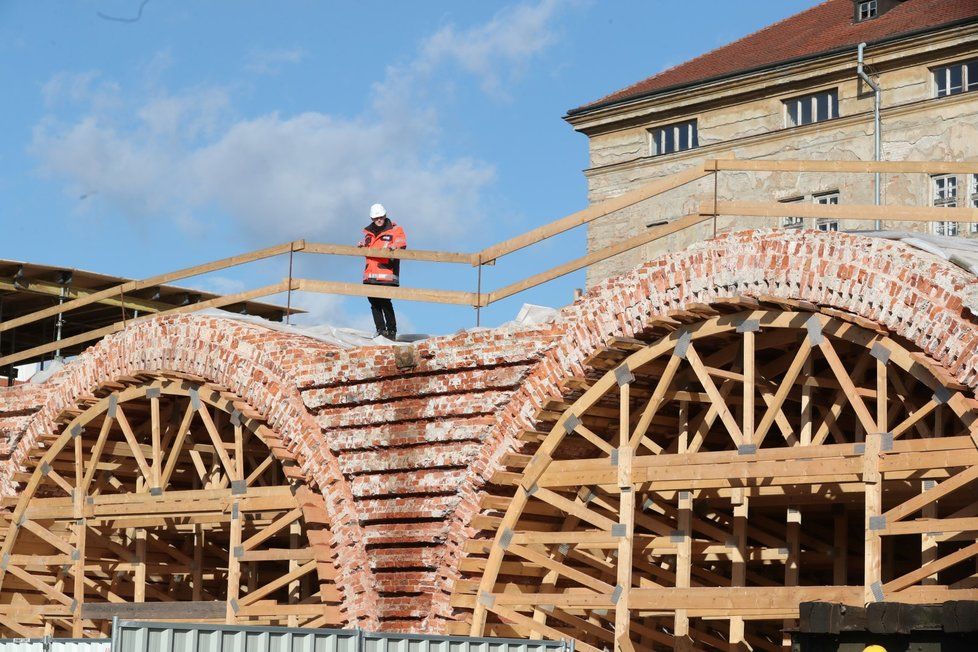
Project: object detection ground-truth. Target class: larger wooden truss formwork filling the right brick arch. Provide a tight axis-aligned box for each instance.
[453,310,978,651]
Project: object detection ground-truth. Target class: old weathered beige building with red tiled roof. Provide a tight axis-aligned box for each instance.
[565,0,978,285]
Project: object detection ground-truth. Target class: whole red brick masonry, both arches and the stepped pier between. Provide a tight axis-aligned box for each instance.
[0,231,978,633]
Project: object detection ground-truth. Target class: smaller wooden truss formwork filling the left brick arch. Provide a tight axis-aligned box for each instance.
[0,374,344,637]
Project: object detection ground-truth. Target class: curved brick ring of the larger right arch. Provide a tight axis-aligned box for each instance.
[438,230,978,628]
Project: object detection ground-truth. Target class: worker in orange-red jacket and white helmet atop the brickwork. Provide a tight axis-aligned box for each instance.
[359,204,407,340]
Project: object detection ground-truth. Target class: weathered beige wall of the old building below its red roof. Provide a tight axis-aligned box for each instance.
[567,25,978,286]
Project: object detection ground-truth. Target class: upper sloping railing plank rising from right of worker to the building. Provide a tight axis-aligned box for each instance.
[476,166,710,264]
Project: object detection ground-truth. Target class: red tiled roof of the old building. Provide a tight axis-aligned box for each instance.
[570,0,978,114]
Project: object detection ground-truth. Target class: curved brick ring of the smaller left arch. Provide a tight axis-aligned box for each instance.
[0,315,376,626]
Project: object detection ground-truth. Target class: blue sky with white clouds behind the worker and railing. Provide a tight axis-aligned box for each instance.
[0,0,814,333]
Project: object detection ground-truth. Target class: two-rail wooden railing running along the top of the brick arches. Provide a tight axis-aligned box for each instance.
[0,159,978,367]
